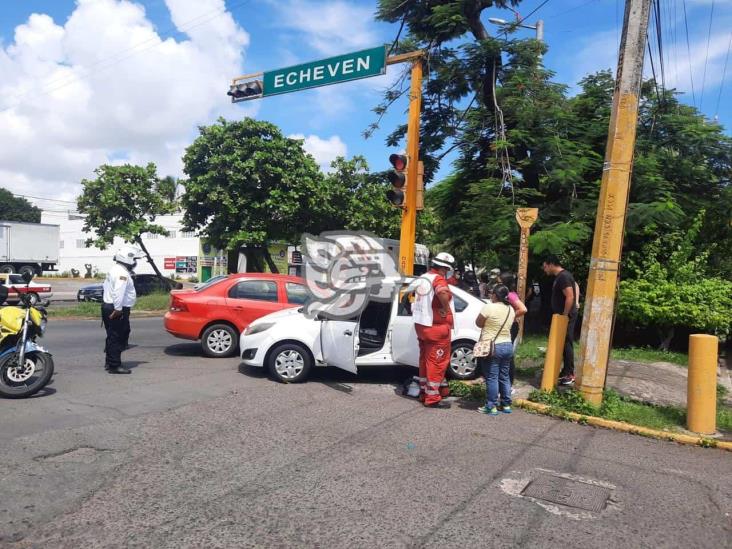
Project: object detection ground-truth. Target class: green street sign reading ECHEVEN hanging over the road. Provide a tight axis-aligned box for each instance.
[262,46,386,97]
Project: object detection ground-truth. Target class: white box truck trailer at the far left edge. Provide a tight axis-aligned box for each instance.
[0,220,60,275]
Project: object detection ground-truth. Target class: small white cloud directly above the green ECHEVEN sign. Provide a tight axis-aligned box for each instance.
[275,0,380,55]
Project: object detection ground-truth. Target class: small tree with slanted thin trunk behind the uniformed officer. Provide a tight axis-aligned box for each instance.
[77,163,175,278]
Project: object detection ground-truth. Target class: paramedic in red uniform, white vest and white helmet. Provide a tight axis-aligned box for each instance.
[412,252,455,408]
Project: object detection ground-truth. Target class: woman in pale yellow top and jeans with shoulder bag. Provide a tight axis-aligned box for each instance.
[475,284,516,416]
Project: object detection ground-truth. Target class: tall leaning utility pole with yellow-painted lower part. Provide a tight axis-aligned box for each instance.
[576,0,651,406]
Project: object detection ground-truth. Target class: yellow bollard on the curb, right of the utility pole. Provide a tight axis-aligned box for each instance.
[686,334,719,435]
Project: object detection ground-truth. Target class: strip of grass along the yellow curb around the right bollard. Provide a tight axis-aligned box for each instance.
[529,389,732,433]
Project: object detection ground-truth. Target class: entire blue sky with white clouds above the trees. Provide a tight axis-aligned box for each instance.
[0,0,732,203]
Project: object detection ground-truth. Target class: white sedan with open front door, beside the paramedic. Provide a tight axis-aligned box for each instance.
[239,278,484,383]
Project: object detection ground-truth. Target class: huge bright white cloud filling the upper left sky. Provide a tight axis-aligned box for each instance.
[0,0,249,201]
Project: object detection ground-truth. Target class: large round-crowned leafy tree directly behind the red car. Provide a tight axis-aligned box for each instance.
[181,118,335,272]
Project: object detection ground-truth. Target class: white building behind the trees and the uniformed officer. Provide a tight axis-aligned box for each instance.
[41,211,227,280]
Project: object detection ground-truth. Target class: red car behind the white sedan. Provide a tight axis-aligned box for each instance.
[165,273,308,358]
